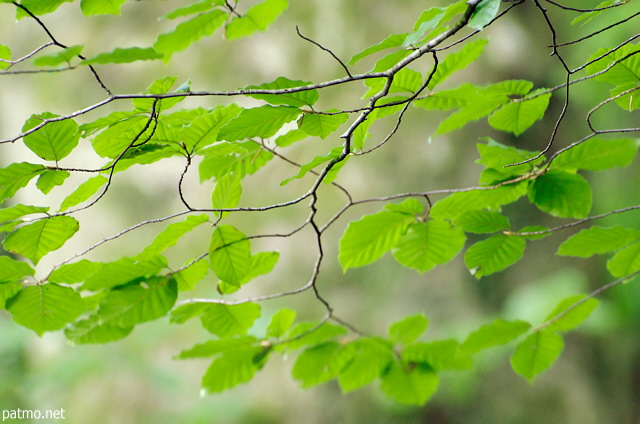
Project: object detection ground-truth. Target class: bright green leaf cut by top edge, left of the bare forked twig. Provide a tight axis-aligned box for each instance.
[225,0,289,40]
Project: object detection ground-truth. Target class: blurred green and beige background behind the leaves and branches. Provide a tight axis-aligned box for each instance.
[0,0,640,424]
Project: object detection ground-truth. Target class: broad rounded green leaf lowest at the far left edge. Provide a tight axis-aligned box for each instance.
[6,283,84,336]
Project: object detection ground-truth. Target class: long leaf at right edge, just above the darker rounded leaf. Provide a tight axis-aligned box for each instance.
[551,138,638,171]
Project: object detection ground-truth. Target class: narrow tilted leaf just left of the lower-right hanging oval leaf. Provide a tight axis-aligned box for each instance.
[460,319,531,354]
